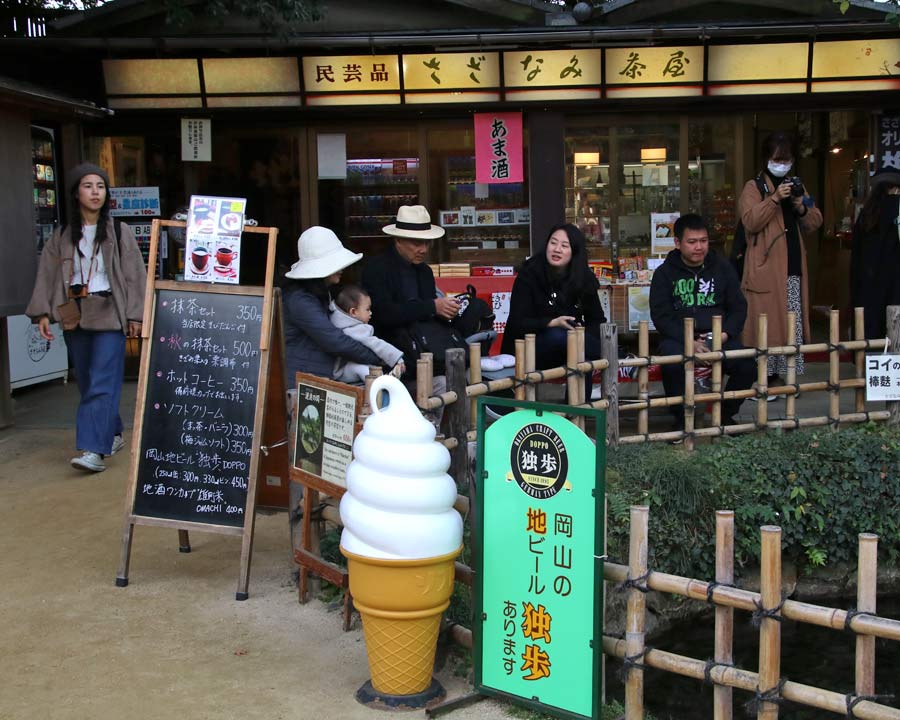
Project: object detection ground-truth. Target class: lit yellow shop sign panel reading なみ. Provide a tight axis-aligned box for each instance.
[503,48,603,88]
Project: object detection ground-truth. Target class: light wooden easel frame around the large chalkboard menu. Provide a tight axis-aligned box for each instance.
[116,219,284,600]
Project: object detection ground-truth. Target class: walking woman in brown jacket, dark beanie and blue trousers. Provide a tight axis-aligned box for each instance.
[25,163,147,472]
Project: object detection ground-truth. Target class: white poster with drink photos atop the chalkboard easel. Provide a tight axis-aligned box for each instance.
[184,195,247,285]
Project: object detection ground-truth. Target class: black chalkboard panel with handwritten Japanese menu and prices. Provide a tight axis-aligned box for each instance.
[134,290,263,527]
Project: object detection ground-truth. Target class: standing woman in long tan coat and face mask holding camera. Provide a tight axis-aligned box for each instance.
[738,132,822,401]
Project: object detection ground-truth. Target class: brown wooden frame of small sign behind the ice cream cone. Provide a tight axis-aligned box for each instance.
[290,372,365,630]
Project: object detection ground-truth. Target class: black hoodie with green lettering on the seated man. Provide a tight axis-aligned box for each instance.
[650,250,747,341]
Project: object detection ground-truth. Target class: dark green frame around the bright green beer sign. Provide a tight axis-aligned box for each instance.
[472,396,606,720]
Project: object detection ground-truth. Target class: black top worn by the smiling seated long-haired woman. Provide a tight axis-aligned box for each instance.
[502,257,606,355]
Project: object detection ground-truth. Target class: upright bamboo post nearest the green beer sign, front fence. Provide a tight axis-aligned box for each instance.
[625,505,650,720]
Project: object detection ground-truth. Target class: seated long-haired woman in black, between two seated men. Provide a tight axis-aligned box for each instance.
[503,224,606,396]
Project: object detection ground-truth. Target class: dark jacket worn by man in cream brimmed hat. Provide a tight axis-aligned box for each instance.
[362,243,435,340]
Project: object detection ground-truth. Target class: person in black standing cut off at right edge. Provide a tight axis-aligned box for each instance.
[850,167,900,339]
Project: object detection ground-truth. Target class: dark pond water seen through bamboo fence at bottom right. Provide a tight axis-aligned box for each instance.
[606,598,900,720]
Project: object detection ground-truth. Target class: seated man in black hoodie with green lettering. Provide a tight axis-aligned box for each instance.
[650,213,756,427]
